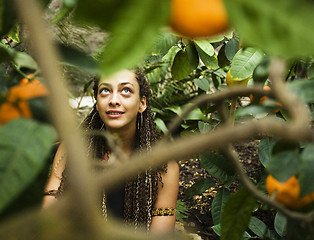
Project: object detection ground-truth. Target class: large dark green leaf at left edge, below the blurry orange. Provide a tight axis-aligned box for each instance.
[0,119,56,211]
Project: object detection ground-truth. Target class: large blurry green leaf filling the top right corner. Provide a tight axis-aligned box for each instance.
[224,0,314,57]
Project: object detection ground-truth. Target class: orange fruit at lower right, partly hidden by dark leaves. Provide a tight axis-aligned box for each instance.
[266,175,314,209]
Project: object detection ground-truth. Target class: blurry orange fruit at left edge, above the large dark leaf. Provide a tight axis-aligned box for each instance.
[0,74,48,125]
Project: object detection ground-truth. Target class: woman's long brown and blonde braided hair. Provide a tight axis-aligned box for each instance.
[82,69,166,230]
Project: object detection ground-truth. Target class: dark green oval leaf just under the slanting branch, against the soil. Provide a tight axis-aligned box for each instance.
[200,152,234,181]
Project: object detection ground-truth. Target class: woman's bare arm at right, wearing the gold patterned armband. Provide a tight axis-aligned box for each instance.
[150,162,179,234]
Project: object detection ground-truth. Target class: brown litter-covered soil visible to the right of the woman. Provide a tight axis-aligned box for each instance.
[178,140,263,240]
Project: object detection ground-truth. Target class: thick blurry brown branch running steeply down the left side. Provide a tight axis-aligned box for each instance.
[14,0,100,230]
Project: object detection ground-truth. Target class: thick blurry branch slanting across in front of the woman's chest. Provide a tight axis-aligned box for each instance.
[101,118,313,192]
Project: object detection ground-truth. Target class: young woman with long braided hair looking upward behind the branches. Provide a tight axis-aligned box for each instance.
[43,70,179,233]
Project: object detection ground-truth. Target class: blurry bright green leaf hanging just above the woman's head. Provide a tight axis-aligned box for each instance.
[100,0,170,75]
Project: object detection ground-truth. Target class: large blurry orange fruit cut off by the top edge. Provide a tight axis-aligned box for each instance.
[170,0,228,38]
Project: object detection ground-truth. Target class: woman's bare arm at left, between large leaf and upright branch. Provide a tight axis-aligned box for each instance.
[42,144,65,208]
